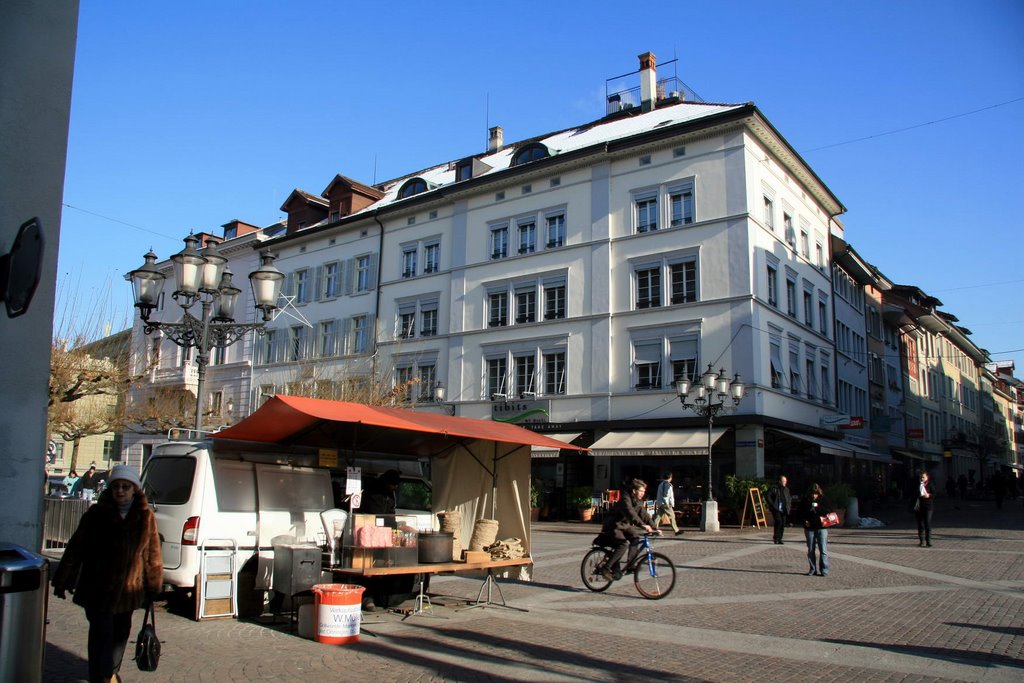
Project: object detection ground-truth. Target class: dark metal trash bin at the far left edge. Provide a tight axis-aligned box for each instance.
[0,543,49,681]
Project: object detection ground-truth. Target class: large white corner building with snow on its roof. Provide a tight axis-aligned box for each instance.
[243,54,854,507]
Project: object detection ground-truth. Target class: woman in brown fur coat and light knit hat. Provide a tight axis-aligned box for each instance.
[53,465,164,683]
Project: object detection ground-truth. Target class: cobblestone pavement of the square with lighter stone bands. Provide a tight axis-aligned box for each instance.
[44,499,1024,683]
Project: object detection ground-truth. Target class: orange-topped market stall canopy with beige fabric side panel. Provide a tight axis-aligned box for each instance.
[212,395,585,565]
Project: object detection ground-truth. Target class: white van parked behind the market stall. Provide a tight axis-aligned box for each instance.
[142,440,335,615]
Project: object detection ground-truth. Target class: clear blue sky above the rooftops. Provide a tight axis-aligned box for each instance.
[57,0,1024,376]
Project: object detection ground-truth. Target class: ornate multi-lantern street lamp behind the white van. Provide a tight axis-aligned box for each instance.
[128,234,285,432]
